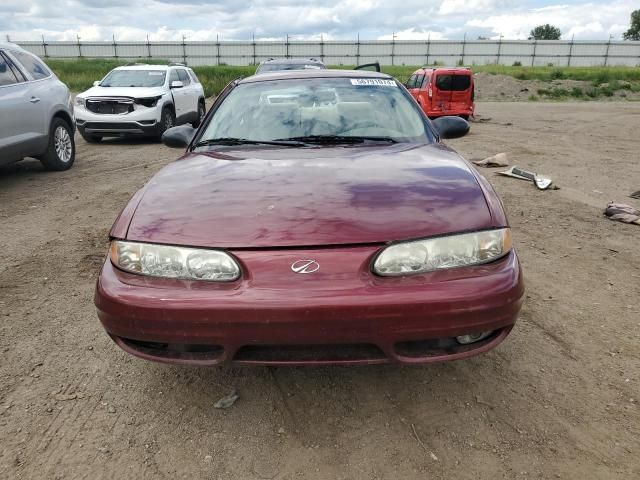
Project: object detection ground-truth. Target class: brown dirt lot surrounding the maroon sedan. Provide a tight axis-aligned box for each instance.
[0,102,640,480]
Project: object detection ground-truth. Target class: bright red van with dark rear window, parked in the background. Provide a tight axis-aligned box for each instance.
[405,67,475,120]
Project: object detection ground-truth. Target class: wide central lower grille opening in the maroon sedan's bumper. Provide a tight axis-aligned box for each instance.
[233,343,386,362]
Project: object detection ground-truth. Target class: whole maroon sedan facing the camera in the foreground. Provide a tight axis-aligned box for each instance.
[95,70,524,365]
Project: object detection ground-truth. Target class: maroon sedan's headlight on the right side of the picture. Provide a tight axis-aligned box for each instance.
[373,228,512,277]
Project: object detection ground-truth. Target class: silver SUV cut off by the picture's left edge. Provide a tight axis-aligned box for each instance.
[0,42,76,170]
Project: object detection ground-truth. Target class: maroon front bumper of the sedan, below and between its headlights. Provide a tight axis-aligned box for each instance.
[95,247,524,365]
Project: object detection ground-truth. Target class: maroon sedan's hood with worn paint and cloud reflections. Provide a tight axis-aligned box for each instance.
[127,144,492,248]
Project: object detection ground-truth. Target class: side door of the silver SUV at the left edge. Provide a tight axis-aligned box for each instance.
[0,50,46,164]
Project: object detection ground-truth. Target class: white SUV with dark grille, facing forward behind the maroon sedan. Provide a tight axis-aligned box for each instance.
[75,64,206,142]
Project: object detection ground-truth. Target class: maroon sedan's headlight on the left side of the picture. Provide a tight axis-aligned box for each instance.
[111,240,240,282]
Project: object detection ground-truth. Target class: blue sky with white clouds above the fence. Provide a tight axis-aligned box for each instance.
[0,0,640,41]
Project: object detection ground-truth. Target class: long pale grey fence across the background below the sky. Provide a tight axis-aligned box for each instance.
[11,37,640,67]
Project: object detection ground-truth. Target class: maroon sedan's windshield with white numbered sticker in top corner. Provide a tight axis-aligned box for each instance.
[199,78,432,143]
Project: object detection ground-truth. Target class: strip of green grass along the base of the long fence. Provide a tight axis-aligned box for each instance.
[47,59,640,98]
